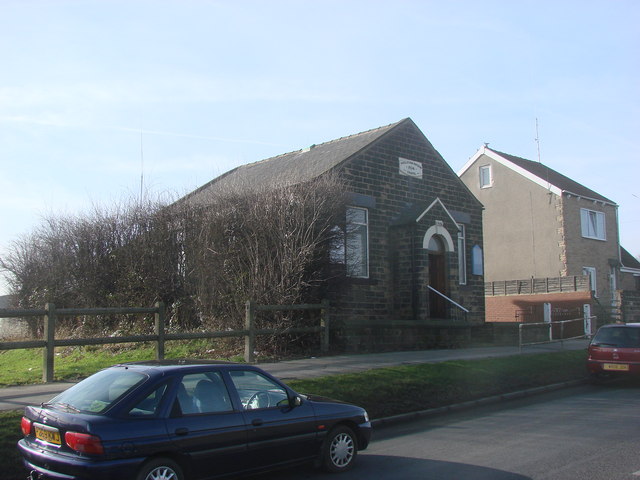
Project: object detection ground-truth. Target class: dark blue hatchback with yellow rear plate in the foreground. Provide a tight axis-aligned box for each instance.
[18,361,371,480]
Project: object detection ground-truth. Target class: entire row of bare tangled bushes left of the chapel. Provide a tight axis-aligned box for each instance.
[0,175,345,349]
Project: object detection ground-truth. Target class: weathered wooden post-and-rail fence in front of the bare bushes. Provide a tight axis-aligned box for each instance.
[0,301,329,382]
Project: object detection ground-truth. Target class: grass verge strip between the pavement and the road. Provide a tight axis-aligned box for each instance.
[0,350,586,480]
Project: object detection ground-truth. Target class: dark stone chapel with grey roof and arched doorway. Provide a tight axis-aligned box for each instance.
[185,118,484,350]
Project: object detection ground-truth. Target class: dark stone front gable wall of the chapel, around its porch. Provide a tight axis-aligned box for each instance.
[330,118,484,348]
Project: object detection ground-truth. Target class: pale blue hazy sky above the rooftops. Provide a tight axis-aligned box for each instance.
[0,0,640,294]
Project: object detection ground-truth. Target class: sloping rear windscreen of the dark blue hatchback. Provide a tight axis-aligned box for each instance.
[45,368,148,413]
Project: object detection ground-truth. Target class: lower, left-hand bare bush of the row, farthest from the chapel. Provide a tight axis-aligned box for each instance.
[0,195,180,332]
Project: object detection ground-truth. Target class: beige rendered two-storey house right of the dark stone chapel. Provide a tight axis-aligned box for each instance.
[458,146,633,320]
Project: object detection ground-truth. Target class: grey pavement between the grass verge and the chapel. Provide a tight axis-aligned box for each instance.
[0,339,589,410]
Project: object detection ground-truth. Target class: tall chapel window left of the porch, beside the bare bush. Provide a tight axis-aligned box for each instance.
[345,207,369,278]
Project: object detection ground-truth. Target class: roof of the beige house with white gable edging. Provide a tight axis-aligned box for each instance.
[458,145,616,205]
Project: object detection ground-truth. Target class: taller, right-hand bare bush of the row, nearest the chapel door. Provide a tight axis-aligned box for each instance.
[181,176,345,336]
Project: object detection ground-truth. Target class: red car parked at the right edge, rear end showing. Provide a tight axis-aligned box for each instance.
[587,323,640,382]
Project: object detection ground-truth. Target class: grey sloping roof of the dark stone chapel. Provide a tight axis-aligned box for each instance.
[180,118,413,203]
